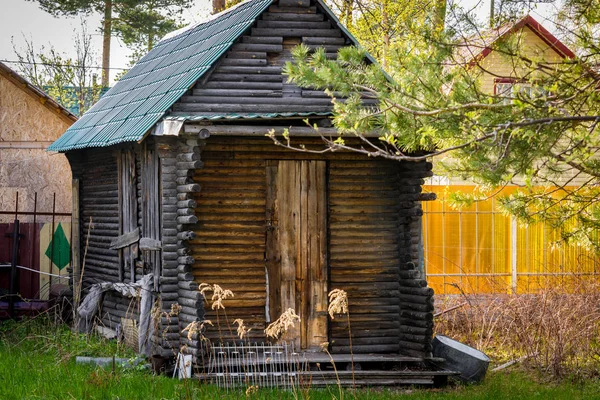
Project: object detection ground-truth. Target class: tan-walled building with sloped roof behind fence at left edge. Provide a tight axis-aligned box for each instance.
[0,63,77,306]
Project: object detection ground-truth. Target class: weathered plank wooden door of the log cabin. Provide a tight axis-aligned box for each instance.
[265,161,327,350]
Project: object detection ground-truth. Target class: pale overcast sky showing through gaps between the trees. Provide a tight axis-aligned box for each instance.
[0,0,555,85]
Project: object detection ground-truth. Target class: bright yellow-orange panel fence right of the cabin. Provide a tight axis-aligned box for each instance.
[423,185,600,294]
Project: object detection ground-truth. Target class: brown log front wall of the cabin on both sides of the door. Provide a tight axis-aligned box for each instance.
[189,137,431,353]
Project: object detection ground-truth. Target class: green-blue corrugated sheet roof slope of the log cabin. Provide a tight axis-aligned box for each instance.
[48,0,273,151]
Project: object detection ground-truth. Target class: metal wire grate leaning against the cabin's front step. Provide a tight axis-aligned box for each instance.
[201,343,307,389]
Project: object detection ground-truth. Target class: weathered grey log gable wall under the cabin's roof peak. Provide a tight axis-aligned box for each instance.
[171,2,376,116]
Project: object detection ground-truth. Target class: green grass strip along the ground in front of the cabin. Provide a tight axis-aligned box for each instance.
[0,321,600,400]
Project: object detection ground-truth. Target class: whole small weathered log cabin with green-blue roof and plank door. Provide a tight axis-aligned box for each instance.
[51,0,433,378]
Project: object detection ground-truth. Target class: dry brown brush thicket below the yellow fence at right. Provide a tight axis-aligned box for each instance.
[435,281,600,378]
